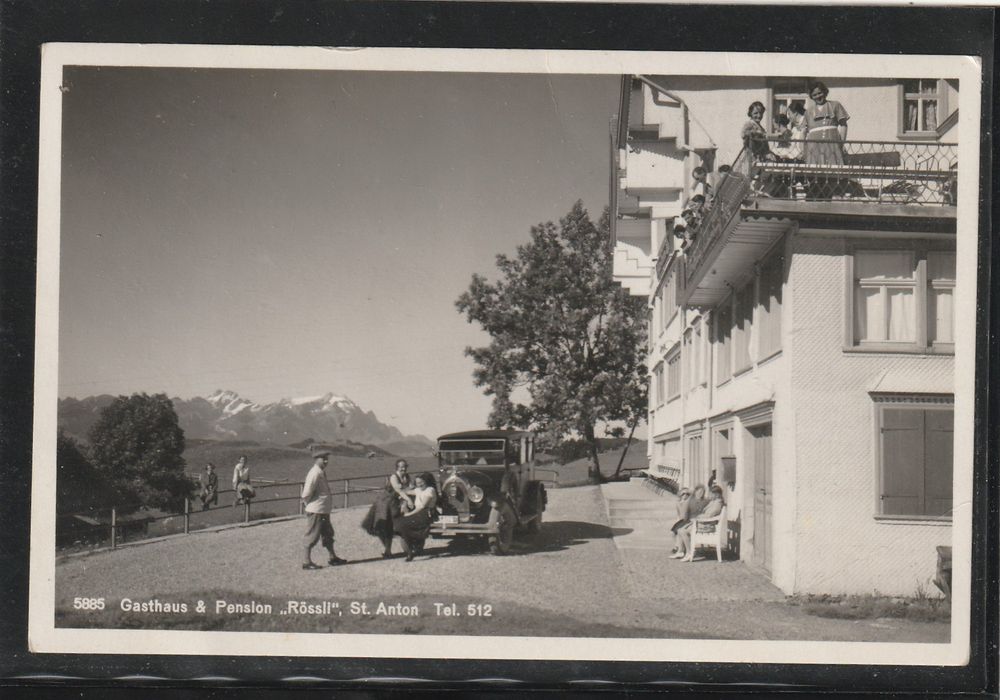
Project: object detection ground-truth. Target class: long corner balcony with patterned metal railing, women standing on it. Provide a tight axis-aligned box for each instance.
[676,141,958,306]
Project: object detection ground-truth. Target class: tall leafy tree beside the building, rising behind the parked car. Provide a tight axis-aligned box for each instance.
[456,201,646,481]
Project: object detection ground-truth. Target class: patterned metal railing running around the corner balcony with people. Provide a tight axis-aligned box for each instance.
[676,139,958,288]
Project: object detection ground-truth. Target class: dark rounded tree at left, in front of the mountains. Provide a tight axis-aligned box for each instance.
[90,393,194,509]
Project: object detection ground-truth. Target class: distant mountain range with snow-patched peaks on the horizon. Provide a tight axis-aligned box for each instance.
[58,390,433,456]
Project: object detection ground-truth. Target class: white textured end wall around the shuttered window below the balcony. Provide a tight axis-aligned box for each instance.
[784,236,954,595]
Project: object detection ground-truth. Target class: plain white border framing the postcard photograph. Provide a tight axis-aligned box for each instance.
[28,43,982,665]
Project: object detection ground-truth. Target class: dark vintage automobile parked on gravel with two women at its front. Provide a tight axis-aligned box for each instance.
[431,430,548,554]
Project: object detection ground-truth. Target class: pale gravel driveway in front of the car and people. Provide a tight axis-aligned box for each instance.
[56,486,948,642]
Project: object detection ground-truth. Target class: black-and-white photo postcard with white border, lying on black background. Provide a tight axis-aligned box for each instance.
[29,44,981,665]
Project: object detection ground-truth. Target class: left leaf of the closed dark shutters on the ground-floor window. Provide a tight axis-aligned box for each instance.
[881,408,924,515]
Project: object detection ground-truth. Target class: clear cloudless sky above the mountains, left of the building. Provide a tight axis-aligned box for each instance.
[59,67,619,438]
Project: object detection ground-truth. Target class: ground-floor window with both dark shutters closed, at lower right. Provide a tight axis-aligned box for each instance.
[876,397,954,517]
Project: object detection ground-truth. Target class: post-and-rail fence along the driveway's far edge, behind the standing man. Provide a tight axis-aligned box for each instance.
[56,475,386,550]
